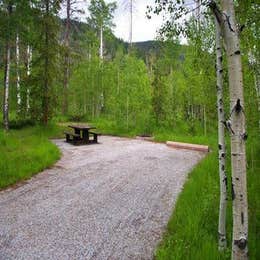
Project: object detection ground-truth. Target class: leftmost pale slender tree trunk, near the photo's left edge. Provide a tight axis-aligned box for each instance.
[3,41,11,130]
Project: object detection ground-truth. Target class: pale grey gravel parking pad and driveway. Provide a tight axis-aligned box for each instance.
[0,136,204,260]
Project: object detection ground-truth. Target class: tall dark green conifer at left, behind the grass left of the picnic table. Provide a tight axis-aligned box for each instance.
[30,0,61,125]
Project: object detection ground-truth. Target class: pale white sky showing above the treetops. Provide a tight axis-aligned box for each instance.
[61,0,163,42]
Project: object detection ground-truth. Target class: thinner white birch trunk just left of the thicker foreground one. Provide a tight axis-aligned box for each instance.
[215,15,227,250]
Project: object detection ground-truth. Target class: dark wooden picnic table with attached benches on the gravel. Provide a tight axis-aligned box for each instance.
[64,124,100,145]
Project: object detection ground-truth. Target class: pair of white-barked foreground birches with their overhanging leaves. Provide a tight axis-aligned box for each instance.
[148,0,259,259]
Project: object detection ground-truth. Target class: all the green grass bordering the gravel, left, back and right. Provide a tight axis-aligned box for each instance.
[0,119,260,260]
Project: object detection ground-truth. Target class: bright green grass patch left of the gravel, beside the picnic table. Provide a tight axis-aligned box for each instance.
[0,126,62,189]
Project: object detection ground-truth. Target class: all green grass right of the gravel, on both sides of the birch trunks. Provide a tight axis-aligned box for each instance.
[155,133,260,260]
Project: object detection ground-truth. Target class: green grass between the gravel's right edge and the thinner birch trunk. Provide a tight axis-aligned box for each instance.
[155,134,230,259]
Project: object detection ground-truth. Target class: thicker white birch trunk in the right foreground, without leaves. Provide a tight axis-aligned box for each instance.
[218,0,248,260]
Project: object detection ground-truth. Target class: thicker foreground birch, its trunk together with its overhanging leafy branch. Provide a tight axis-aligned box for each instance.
[148,0,248,259]
